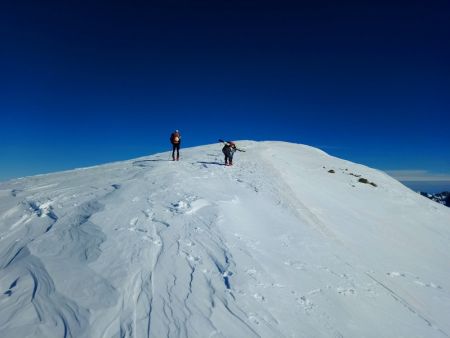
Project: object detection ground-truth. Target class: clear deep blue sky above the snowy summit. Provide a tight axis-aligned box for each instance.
[0,0,450,190]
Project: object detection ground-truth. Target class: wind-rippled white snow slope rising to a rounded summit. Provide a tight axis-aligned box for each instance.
[0,141,450,338]
